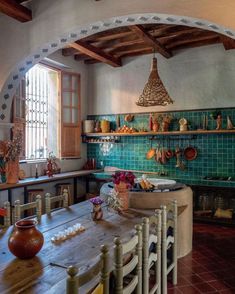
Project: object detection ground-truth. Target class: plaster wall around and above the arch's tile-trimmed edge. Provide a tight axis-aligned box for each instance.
[0,0,235,108]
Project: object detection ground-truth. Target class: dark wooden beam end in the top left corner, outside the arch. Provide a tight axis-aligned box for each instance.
[0,0,32,22]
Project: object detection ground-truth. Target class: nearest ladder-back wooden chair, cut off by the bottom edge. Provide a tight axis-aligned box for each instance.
[66,245,109,294]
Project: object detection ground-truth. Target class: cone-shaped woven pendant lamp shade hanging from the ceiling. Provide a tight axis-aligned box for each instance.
[136,57,173,107]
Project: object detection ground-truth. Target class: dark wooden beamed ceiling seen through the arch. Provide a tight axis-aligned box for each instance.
[62,24,235,66]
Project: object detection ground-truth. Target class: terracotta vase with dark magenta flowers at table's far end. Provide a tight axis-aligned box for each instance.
[112,171,135,210]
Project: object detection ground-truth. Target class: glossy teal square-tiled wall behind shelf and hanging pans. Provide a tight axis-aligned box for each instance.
[87,108,235,186]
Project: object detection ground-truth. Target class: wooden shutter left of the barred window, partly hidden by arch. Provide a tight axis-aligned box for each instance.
[12,78,26,160]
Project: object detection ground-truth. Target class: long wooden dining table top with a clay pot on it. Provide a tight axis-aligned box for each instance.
[0,201,147,294]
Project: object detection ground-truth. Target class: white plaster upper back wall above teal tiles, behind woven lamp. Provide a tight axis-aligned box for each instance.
[88,45,235,114]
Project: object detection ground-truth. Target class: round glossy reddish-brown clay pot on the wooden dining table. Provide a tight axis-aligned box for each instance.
[8,219,44,259]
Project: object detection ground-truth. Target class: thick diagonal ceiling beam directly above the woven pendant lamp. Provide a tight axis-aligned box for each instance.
[129,25,172,58]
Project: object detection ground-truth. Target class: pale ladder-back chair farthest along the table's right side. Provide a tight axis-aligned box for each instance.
[161,200,178,294]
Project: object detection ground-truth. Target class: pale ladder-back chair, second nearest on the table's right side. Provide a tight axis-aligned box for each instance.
[114,225,142,294]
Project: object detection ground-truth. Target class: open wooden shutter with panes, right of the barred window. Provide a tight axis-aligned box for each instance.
[60,72,81,158]
